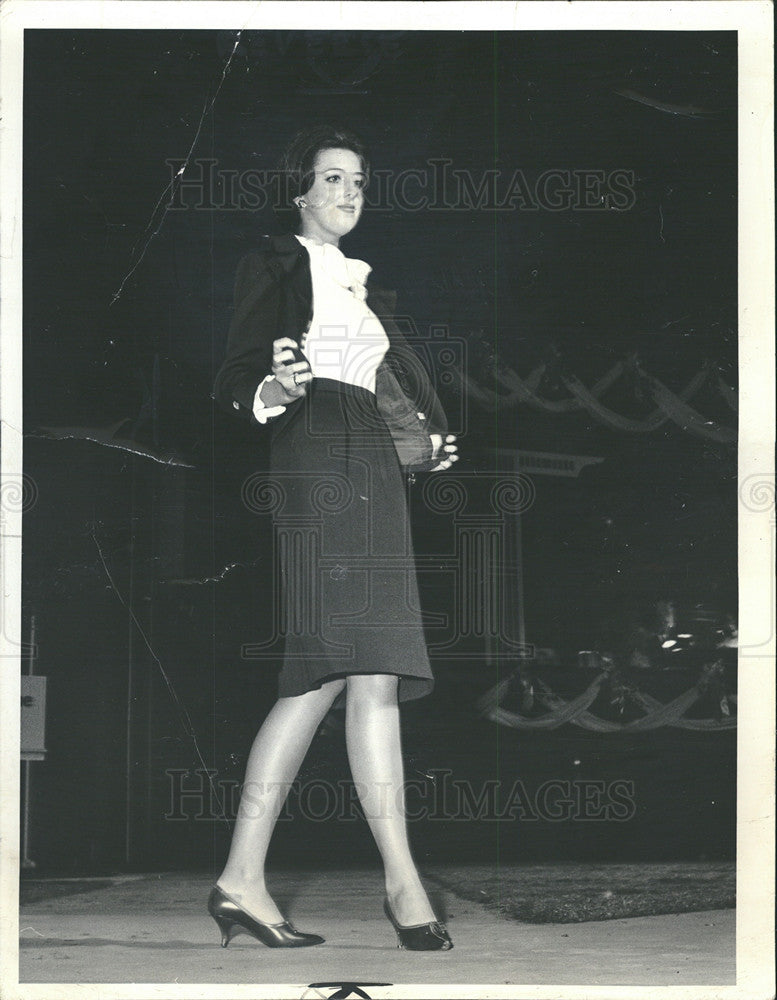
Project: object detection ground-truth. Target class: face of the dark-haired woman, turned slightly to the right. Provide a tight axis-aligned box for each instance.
[300,149,367,246]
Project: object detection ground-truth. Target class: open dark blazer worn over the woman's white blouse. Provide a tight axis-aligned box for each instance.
[214,234,447,469]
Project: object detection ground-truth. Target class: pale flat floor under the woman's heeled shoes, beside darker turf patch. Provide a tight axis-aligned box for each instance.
[19,865,735,984]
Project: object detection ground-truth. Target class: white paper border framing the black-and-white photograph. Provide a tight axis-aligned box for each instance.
[0,0,777,1000]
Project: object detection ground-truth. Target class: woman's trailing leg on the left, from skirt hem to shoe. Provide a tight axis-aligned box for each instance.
[218,680,345,923]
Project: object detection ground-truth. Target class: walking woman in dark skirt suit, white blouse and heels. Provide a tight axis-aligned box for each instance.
[209,126,458,950]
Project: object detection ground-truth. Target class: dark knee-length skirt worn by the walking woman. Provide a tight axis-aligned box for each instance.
[270,378,434,706]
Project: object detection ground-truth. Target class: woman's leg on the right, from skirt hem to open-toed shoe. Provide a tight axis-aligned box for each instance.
[345,674,435,925]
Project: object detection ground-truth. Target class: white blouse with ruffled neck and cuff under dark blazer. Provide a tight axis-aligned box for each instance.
[254,236,389,423]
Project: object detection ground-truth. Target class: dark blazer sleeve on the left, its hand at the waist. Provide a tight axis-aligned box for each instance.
[213,253,281,418]
